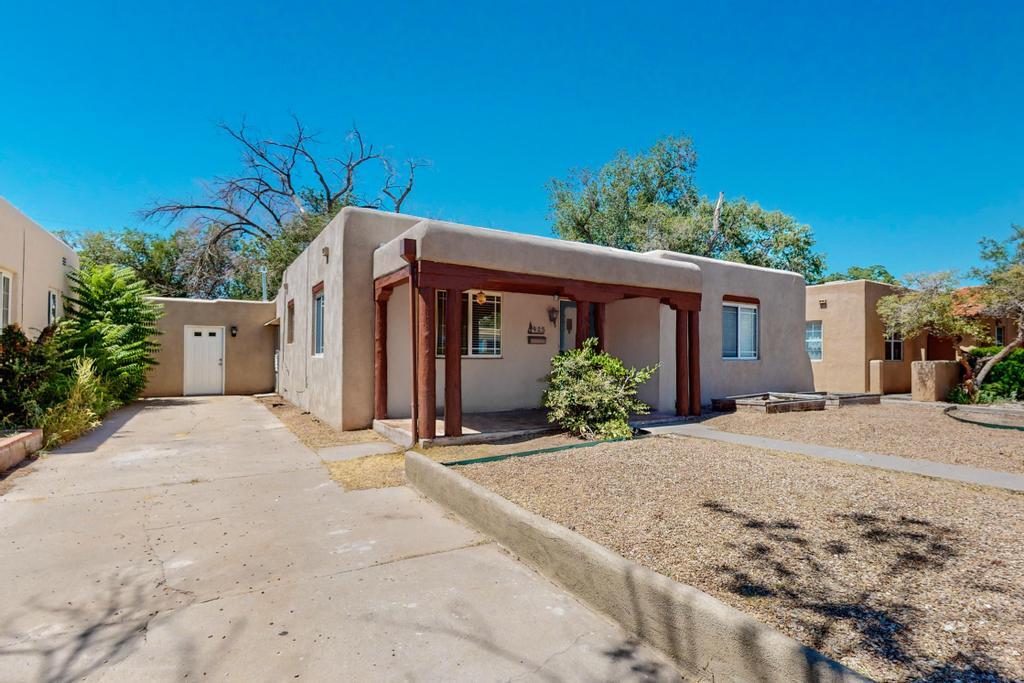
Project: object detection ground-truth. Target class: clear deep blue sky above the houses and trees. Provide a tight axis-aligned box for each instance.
[0,1,1024,274]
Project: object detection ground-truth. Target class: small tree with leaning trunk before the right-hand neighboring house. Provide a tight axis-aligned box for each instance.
[878,271,987,389]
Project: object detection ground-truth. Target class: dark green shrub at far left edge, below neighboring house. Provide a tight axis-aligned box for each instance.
[0,325,67,429]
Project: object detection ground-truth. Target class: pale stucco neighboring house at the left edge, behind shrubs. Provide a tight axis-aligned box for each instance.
[0,197,78,337]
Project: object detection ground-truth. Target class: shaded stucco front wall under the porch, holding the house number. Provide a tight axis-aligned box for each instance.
[387,285,558,418]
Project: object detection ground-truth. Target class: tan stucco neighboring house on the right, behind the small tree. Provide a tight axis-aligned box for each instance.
[804,280,1017,393]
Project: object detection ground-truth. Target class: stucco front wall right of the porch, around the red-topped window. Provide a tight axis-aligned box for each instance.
[648,251,814,401]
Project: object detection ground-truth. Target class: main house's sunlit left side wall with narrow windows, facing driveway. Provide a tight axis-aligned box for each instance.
[275,208,422,429]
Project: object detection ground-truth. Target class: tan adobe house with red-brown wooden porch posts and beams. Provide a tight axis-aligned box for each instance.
[276,208,812,440]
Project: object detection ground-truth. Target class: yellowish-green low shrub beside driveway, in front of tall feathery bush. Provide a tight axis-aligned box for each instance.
[41,358,118,447]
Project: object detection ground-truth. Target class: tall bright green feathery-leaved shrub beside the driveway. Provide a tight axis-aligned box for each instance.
[57,265,162,403]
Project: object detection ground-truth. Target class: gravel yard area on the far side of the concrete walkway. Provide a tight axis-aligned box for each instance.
[703,403,1024,474]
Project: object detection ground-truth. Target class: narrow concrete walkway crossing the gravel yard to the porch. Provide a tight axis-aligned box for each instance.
[646,423,1024,490]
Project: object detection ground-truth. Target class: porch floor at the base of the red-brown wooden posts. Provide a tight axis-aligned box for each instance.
[374,408,686,445]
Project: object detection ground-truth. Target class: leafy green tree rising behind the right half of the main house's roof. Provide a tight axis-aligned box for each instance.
[548,136,824,282]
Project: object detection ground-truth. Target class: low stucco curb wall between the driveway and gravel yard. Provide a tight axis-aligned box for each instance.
[406,452,869,683]
